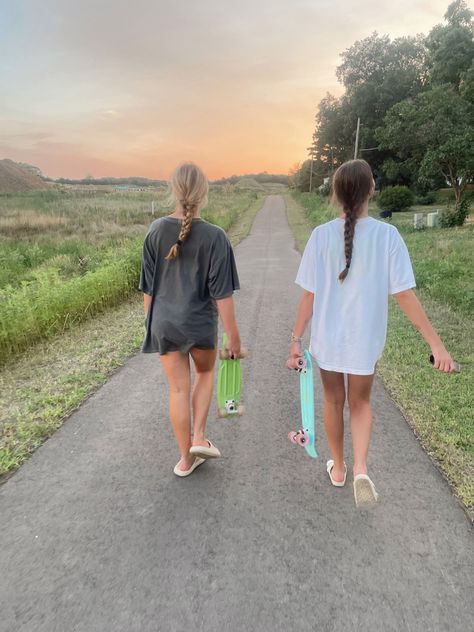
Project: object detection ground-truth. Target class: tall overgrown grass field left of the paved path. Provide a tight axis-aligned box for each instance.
[0,186,262,362]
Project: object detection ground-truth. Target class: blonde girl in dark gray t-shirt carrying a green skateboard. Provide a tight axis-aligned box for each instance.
[139,163,240,476]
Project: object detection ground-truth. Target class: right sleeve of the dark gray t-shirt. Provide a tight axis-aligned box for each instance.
[208,231,240,300]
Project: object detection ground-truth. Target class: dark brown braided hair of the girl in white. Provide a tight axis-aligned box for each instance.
[332,160,374,282]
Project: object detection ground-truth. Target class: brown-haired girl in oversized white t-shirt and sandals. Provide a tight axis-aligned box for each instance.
[287,160,455,506]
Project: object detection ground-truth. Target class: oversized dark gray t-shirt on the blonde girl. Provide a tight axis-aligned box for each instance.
[139,217,240,354]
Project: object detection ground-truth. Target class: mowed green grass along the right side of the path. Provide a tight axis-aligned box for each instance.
[287,194,474,518]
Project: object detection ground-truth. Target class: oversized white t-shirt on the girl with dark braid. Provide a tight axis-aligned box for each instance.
[296,217,415,375]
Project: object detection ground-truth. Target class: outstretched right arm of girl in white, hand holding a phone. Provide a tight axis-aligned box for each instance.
[394,290,455,373]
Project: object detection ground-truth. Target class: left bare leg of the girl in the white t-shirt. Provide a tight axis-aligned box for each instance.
[320,369,346,483]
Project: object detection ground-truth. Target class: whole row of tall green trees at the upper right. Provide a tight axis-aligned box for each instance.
[290,0,474,206]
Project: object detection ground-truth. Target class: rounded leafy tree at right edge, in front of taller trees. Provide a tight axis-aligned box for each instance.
[377,84,474,208]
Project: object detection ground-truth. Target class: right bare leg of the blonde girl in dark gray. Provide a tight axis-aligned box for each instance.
[191,348,217,446]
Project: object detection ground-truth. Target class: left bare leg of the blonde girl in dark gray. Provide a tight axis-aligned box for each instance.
[160,351,194,470]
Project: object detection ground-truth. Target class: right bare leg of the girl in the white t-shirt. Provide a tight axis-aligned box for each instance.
[347,375,374,476]
